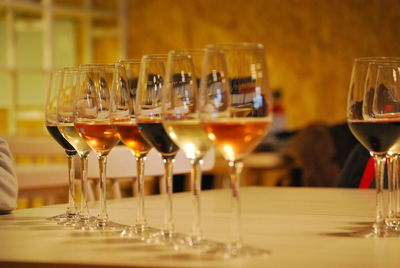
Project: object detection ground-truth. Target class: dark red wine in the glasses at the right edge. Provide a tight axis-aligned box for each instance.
[348,120,400,153]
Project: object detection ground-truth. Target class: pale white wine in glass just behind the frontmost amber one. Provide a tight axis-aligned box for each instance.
[164,120,212,159]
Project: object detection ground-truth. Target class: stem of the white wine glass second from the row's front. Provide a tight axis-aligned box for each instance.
[190,159,202,241]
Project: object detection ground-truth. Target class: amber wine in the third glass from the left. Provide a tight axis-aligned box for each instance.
[75,123,119,155]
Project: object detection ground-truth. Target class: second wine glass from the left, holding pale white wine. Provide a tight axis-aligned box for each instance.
[57,67,91,229]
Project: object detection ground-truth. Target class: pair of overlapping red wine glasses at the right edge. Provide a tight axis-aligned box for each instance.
[347,58,400,237]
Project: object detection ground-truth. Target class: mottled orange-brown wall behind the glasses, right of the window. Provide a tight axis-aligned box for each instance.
[128,0,400,128]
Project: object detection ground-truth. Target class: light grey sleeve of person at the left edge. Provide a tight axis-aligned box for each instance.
[0,137,18,214]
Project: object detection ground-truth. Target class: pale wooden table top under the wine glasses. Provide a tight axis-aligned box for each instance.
[0,187,400,267]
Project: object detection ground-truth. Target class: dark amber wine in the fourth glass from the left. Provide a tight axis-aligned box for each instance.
[113,122,151,157]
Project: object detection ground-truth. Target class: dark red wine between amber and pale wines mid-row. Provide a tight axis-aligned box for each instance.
[138,121,179,156]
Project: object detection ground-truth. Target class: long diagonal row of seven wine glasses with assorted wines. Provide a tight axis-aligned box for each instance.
[46,43,272,257]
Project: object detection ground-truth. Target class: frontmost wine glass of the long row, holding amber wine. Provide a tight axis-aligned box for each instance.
[199,43,272,258]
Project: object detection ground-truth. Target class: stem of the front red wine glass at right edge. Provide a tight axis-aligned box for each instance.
[374,154,386,233]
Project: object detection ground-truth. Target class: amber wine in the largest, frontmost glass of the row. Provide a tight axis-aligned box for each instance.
[203,118,271,161]
